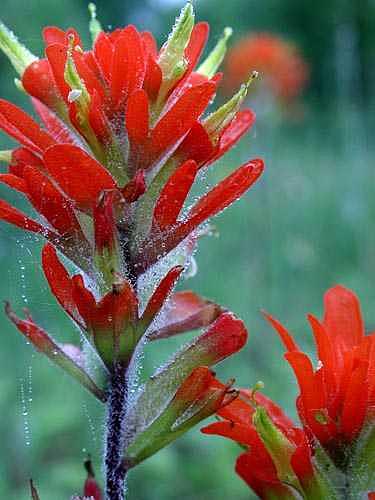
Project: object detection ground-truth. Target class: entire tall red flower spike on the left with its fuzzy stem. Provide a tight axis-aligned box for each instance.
[0,3,263,498]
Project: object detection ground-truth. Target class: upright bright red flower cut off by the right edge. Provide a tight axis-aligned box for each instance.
[266,286,375,466]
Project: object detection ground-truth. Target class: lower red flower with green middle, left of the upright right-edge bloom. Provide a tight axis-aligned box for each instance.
[202,383,323,499]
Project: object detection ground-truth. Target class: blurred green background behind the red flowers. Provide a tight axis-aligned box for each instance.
[0,0,375,500]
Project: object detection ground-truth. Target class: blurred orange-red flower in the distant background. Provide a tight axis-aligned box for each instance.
[224,33,309,102]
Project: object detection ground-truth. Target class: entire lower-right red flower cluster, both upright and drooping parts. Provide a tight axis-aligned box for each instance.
[203,286,375,500]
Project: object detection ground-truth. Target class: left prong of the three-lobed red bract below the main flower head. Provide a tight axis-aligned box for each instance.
[42,243,81,323]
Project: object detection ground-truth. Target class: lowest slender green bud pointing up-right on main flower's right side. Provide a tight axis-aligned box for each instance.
[203,71,258,143]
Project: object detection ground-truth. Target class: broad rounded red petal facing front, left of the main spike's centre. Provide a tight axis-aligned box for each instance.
[44,144,116,210]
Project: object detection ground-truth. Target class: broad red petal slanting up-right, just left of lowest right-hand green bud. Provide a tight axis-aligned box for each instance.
[150,82,216,168]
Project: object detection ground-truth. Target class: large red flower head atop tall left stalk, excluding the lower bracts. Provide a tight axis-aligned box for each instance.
[0,10,263,282]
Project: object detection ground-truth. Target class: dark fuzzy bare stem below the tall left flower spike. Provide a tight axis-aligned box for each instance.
[105,363,129,500]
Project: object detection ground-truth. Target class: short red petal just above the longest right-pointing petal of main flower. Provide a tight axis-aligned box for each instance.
[153,160,198,232]
